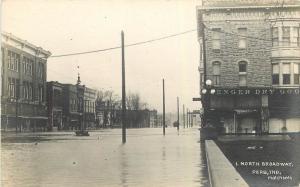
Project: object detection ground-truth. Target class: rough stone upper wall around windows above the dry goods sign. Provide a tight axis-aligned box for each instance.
[205,20,272,87]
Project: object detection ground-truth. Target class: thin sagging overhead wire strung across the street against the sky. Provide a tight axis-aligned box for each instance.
[49,29,197,58]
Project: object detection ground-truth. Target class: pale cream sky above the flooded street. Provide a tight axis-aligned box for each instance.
[1,0,200,112]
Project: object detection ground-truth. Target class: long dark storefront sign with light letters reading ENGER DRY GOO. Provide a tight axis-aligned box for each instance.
[214,88,300,95]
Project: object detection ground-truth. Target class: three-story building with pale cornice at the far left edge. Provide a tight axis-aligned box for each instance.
[1,33,51,131]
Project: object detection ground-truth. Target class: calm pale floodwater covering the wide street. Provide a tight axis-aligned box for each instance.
[1,128,208,187]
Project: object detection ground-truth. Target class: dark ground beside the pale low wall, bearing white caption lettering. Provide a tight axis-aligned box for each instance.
[216,133,300,187]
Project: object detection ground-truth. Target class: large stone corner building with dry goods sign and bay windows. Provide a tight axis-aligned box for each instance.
[197,0,300,133]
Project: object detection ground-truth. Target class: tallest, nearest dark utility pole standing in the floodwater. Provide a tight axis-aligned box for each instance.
[121,31,127,143]
